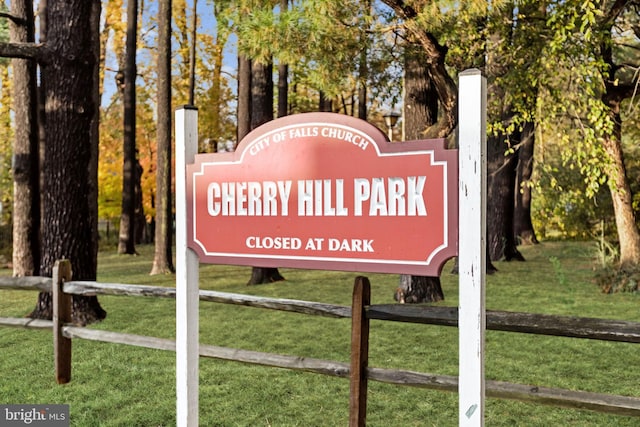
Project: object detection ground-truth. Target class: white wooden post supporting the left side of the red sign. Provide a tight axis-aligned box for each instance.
[176,106,200,427]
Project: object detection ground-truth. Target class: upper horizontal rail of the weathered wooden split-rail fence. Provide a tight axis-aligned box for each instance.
[0,277,640,343]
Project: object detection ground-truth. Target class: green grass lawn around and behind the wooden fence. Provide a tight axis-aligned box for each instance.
[0,242,640,427]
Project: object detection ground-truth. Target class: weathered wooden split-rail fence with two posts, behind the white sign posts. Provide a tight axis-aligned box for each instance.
[0,261,640,425]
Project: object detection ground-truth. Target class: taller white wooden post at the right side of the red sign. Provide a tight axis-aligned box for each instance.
[458,69,487,426]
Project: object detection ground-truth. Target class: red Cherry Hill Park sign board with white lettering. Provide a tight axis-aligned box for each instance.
[187,113,458,275]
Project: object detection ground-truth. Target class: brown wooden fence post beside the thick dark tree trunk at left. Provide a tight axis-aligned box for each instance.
[51,260,71,384]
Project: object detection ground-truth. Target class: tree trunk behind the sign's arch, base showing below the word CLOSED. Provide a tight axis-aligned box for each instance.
[247,62,284,285]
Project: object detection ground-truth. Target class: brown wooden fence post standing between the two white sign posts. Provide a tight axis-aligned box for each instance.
[349,276,371,427]
